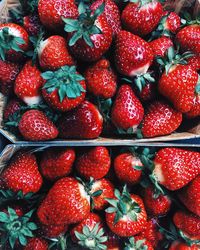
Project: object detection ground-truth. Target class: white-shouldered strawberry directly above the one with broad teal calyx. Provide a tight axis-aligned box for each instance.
[38,36,74,70]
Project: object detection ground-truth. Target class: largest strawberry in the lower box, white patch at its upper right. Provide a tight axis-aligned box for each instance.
[37,177,90,225]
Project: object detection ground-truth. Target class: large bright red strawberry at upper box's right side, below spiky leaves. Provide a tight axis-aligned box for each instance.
[158,64,198,113]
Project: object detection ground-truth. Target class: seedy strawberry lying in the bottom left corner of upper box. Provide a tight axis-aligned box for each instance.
[18,110,58,141]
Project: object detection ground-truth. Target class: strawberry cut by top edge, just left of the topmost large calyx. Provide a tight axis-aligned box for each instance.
[38,0,78,30]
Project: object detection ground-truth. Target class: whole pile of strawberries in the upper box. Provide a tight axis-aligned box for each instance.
[0,0,200,141]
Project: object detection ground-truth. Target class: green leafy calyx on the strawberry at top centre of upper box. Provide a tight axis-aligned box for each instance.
[63,2,105,47]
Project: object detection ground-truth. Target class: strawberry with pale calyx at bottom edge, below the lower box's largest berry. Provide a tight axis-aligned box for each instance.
[70,213,107,249]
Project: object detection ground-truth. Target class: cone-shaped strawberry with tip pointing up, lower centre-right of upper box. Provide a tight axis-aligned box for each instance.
[111,84,144,131]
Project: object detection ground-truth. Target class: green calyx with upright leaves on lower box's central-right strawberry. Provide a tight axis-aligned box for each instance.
[105,185,141,223]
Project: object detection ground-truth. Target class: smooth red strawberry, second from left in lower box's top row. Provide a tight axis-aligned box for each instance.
[40,148,75,181]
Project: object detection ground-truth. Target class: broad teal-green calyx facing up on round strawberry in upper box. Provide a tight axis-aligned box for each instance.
[41,66,85,102]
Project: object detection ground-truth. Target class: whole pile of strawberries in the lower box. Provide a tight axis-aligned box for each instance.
[0,146,200,250]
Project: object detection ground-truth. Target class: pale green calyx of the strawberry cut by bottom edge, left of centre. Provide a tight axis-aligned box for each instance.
[74,223,108,250]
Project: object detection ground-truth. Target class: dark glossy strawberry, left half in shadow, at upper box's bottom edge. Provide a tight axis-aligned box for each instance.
[58,101,103,139]
